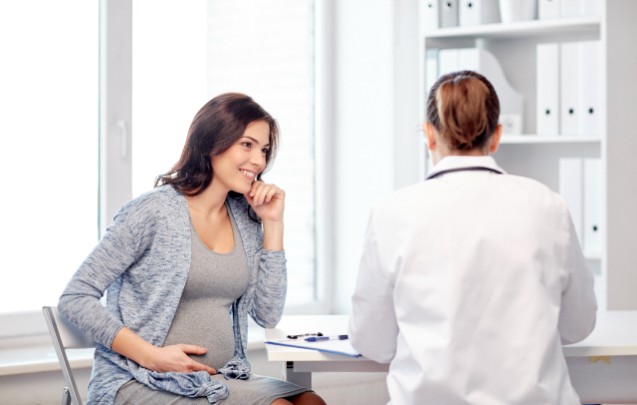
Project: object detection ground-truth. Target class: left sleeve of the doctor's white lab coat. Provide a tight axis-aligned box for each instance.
[349,211,398,363]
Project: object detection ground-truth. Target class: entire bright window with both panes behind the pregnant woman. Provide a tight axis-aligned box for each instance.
[0,0,317,335]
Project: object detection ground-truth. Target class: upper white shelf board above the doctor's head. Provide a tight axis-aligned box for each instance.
[425,17,600,39]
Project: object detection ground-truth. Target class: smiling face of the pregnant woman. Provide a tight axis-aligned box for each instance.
[212,121,270,194]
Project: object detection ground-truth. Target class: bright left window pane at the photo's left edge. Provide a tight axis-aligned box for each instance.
[0,0,98,318]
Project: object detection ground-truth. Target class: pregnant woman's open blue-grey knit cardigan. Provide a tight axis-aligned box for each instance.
[58,186,287,404]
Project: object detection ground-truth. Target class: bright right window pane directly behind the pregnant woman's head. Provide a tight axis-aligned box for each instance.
[133,0,317,306]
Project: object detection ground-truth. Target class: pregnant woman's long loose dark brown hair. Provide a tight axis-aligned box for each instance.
[155,93,279,196]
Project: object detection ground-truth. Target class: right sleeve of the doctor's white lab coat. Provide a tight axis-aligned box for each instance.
[559,216,597,344]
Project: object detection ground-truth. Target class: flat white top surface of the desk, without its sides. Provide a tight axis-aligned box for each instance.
[265,311,637,362]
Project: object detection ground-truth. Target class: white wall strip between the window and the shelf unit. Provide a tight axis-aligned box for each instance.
[333,0,419,313]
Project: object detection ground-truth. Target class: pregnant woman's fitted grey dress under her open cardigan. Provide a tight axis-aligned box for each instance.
[115,210,307,405]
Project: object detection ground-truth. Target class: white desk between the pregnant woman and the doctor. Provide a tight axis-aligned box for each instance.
[265,311,637,404]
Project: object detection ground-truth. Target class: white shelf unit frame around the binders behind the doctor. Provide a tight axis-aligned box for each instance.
[420,0,637,310]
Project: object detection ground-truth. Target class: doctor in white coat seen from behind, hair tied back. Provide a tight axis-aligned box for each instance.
[349,71,597,405]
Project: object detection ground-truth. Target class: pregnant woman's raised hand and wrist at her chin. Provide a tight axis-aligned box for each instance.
[245,181,285,250]
